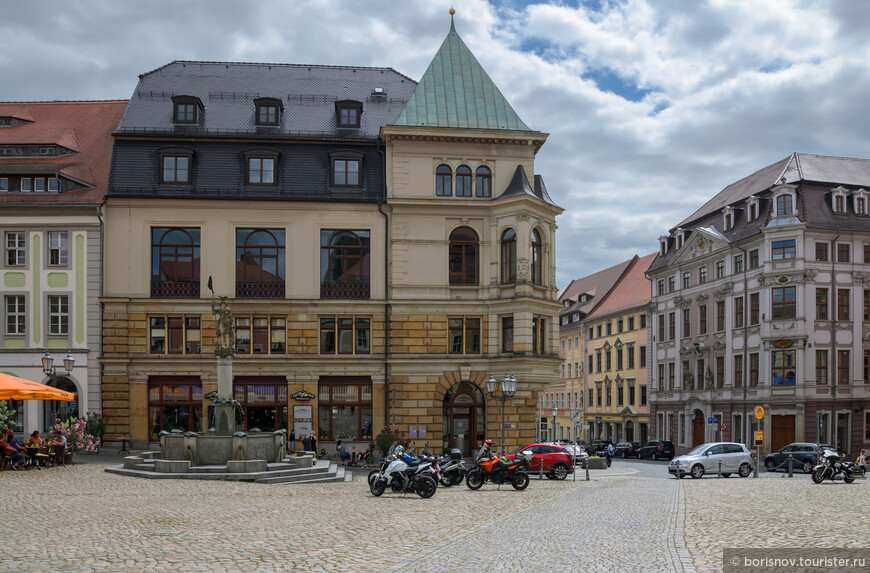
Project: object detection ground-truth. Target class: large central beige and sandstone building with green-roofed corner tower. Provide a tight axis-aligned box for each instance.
[102,22,562,455]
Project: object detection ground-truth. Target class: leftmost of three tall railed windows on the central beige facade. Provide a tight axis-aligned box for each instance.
[151,227,200,298]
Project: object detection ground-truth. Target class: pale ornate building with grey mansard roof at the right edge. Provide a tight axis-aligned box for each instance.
[648,153,870,457]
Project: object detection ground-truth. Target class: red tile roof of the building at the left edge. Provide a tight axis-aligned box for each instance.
[0,100,128,205]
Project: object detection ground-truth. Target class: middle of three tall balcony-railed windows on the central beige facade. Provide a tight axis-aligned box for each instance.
[236,229,285,298]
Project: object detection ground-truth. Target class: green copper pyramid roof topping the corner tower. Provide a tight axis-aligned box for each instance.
[395,16,532,131]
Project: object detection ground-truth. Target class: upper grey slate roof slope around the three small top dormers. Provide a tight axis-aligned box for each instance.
[116,61,417,141]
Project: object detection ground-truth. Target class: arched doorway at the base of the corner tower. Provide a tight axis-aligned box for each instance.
[442,382,486,456]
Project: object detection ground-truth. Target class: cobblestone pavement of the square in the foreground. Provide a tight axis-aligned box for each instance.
[0,463,868,573]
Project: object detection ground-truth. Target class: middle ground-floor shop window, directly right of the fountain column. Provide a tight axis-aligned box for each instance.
[233,376,287,432]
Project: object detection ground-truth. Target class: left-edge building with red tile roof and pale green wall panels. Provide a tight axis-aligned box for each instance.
[0,101,127,433]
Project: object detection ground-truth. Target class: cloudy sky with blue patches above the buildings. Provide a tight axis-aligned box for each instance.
[0,0,870,287]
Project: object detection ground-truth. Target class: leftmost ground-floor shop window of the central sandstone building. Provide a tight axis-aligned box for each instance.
[148,376,202,441]
